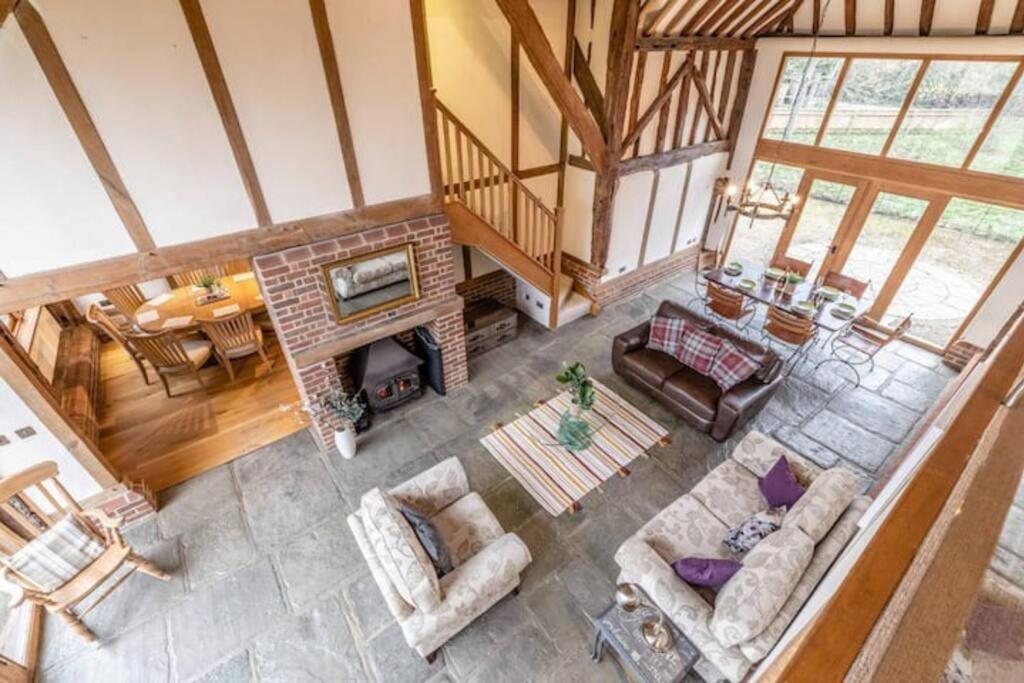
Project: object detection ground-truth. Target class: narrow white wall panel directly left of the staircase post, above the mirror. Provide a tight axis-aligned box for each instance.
[327,0,430,204]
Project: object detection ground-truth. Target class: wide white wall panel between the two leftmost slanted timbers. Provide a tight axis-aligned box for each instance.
[37,0,256,245]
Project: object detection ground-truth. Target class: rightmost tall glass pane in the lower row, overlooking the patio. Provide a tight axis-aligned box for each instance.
[885,199,1024,346]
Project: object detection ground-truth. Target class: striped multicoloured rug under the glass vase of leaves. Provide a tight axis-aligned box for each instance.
[480,380,669,516]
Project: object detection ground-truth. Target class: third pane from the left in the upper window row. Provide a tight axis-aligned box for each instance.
[889,60,1017,167]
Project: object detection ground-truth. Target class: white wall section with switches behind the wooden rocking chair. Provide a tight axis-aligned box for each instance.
[0,379,102,509]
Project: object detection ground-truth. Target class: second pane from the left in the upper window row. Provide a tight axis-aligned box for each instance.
[821,59,921,155]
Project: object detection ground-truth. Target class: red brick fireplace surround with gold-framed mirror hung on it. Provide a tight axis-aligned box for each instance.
[254,214,469,449]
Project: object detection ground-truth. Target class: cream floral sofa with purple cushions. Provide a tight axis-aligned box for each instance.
[615,432,870,681]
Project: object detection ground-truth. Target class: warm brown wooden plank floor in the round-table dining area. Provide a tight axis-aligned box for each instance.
[99,339,309,490]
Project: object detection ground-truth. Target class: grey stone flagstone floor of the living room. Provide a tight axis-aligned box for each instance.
[40,274,952,683]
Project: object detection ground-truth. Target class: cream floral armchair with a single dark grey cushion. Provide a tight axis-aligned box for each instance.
[348,458,532,661]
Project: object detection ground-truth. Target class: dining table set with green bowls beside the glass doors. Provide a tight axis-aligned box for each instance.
[705,259,870,333]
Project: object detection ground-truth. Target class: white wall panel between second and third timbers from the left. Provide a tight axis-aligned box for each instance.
[202,0,354,222]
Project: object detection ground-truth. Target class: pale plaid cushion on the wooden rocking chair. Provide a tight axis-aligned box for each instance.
[6,516,103,593]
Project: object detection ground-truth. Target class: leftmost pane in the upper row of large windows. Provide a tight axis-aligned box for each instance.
[765,57,843,144]
